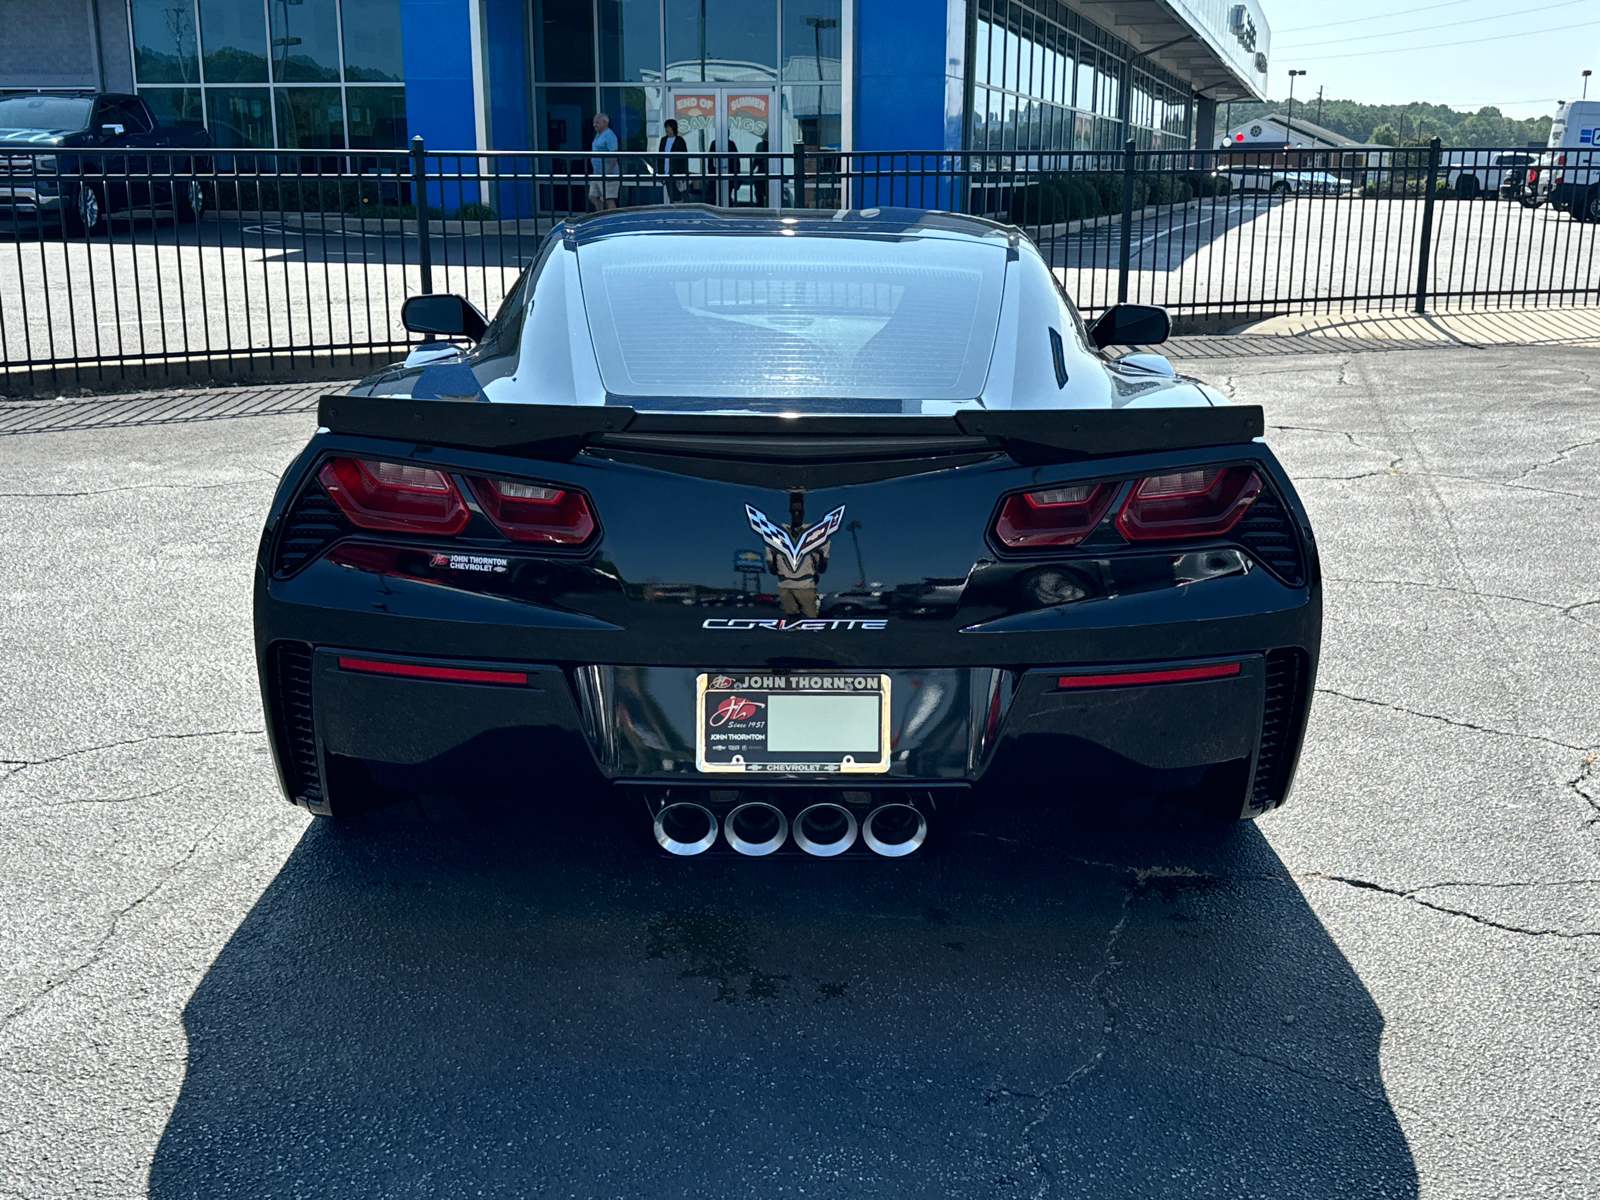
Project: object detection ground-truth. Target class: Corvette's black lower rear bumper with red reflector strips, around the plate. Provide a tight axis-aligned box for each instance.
[261,597,1320,816]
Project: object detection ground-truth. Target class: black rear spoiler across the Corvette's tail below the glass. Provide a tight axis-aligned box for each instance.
[317,395,1266,464]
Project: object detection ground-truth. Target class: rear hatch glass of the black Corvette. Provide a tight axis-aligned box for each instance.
[578,234,1006,411]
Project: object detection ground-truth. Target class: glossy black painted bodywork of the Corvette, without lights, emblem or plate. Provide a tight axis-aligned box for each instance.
[254,214,1322,818]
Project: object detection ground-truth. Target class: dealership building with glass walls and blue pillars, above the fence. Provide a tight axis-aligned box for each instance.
[0,0,1270,162]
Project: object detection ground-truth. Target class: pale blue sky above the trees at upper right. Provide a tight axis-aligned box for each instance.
[1261,0,1600,120]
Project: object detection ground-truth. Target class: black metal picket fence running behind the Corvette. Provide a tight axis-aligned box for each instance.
[0,139,1600,390]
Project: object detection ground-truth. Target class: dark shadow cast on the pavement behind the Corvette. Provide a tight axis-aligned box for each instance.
[149,797,1418,1200]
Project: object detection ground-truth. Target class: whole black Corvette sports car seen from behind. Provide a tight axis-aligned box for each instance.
[256,206,1322,858]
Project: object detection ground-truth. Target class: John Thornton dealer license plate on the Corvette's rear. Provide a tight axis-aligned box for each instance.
[694,670,890,774]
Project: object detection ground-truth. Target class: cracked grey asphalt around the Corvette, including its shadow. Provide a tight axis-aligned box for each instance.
[0,339,1600,1200]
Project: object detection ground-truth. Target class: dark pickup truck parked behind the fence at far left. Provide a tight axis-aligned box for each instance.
[0,91,210,234]
